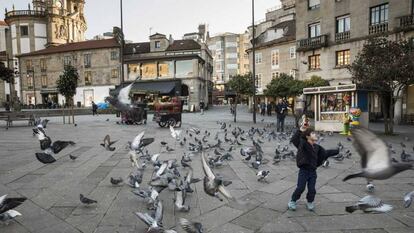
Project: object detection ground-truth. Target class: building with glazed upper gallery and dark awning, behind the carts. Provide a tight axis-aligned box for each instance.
[124,33,213,110]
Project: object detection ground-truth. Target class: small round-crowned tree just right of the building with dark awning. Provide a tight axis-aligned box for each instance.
[226,73,255,122]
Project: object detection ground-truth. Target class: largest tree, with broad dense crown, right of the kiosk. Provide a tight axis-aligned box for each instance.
[348,37,414,134]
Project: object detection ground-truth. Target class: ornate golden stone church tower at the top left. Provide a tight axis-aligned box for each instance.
[47,0,87,46]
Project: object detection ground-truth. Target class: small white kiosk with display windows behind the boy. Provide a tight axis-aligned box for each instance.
[303,84,369,132]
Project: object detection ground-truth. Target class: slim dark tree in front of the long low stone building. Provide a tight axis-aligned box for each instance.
[56,65,79,123]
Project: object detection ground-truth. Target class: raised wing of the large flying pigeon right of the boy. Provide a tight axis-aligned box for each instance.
[353,128,391,169]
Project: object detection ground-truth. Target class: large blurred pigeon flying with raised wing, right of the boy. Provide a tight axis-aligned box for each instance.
[343,128,413,181]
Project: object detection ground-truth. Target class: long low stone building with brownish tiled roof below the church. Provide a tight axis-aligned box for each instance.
[18,38,120,107]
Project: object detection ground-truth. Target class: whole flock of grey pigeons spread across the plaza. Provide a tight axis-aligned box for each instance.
[0,113,414,233]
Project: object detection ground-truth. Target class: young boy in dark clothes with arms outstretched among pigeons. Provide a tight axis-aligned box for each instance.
[288,123,339,211]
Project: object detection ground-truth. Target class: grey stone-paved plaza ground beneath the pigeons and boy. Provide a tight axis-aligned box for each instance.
[0,107,414,233]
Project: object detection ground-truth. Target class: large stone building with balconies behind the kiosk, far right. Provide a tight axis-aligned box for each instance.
[296,0,414,124]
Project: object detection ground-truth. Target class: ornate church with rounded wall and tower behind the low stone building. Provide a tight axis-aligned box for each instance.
[5,0,87,104]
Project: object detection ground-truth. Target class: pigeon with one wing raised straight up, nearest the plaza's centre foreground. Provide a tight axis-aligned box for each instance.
[201,153,234,201]
